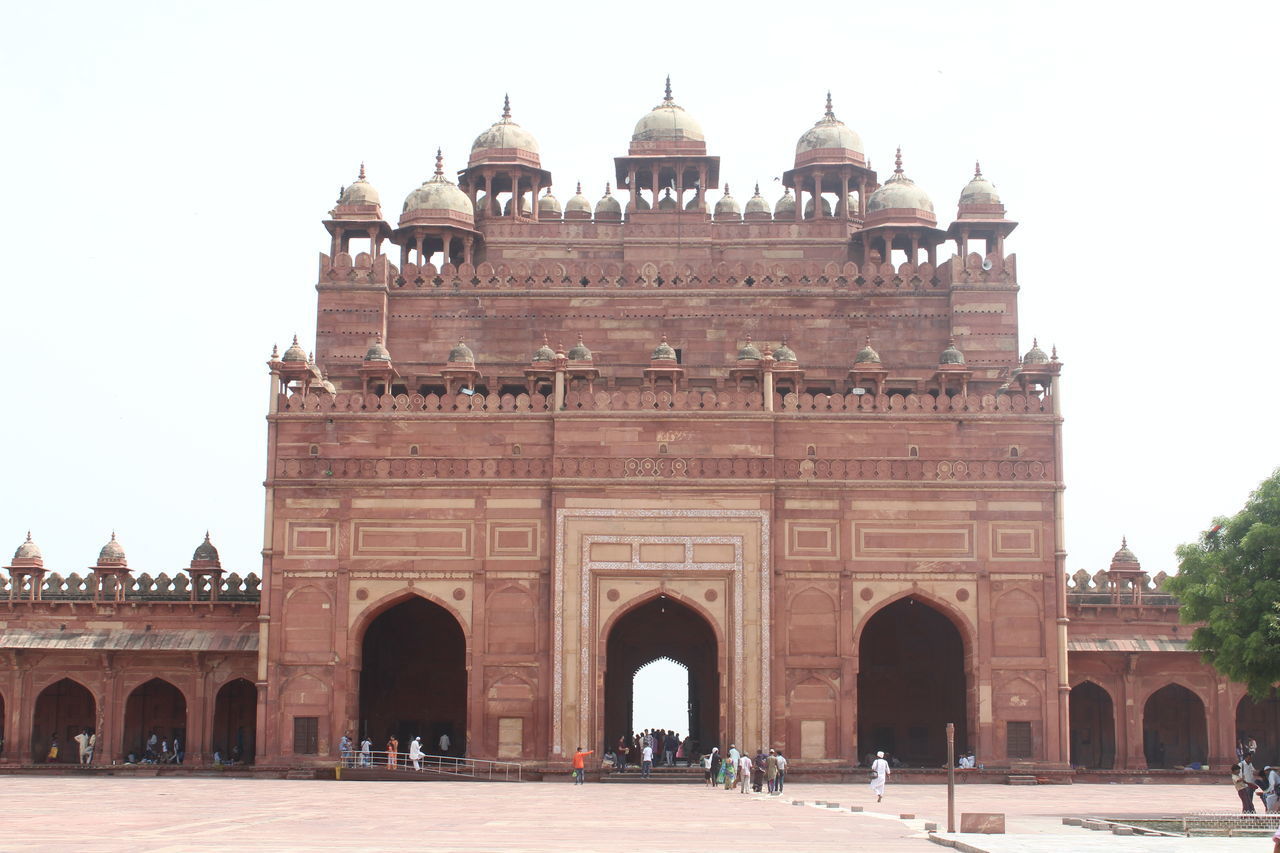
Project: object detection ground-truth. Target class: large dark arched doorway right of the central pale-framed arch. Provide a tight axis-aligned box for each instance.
[858,597,973,767]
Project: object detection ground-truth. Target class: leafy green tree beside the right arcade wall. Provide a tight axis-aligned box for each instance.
[1167,469,1280,698]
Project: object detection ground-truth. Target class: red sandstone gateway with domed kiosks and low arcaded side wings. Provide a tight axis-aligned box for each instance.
[0,82,1259,770]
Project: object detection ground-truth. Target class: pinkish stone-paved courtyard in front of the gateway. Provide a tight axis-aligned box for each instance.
[0,776,1270,853]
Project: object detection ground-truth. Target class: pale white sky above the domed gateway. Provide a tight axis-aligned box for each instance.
[0,1,1280,574]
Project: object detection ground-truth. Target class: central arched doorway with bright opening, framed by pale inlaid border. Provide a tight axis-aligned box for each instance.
[595,596,728,752]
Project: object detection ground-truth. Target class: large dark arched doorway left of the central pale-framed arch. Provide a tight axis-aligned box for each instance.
[355,597,467,756]
